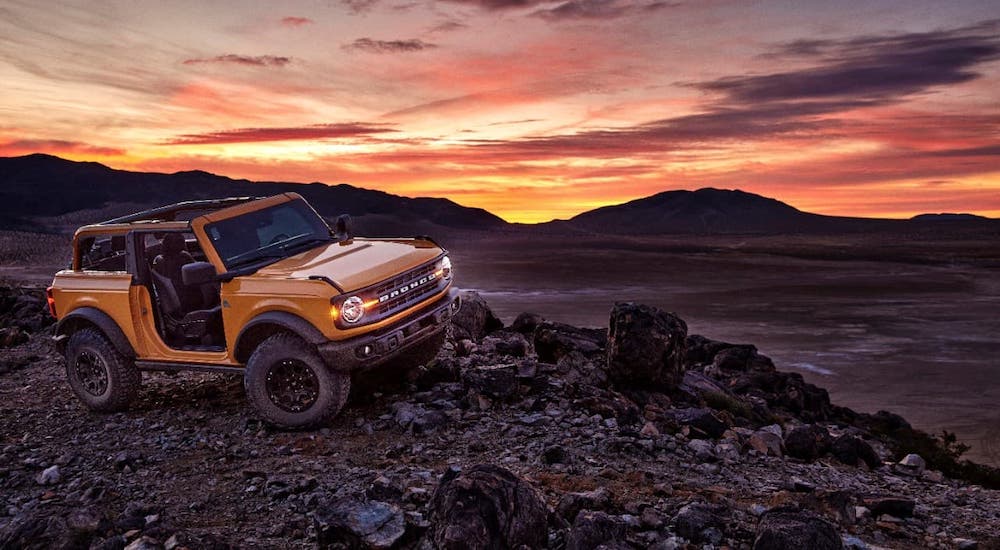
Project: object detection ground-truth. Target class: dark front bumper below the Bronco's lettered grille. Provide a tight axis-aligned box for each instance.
[316,289,462,372]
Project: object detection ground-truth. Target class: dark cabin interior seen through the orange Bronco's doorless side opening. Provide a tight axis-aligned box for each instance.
[140,232,225,350]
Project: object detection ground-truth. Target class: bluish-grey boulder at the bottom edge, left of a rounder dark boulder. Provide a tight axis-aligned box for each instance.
[313,499,406,550]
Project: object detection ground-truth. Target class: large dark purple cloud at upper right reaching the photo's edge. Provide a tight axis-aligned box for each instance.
[695,22,1000,103]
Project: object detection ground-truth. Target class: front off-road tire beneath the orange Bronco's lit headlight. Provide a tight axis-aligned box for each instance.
[243,333,351,429]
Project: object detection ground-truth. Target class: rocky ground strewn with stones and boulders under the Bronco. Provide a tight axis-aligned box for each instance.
[0,289,1000,549]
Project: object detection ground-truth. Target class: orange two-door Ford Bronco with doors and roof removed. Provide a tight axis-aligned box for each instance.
[47,193,460,428]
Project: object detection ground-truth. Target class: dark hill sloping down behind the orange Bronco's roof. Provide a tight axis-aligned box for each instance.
[0,154,507,235]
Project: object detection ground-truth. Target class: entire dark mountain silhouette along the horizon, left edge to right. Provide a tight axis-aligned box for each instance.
[0,154,1000,235]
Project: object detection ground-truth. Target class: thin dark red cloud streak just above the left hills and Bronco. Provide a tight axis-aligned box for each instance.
[165,122,395,145]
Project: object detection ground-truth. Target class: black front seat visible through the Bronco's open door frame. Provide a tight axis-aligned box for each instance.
[151,233,222,345]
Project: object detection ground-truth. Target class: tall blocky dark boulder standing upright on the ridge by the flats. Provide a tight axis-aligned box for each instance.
[607,302,687,390]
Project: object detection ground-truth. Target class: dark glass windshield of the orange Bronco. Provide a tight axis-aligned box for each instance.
[205,200,332,270]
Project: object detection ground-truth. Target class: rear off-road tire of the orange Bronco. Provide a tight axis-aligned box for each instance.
[66,328,142,412]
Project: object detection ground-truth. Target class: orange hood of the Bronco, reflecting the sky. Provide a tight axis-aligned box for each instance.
[255,239,443,292]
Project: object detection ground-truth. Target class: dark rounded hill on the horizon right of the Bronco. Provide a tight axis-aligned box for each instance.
[552,188,997,234]
